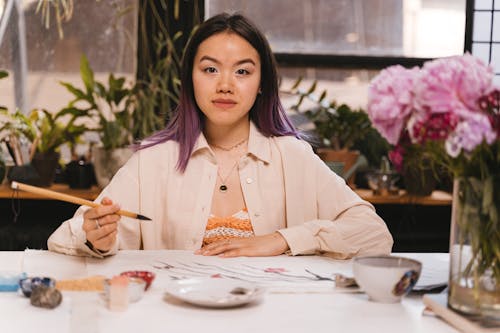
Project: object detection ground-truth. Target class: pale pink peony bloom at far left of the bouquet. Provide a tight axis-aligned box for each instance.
[368,65,419,144]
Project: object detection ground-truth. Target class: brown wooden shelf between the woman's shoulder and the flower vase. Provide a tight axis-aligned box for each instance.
[355,189,452,206]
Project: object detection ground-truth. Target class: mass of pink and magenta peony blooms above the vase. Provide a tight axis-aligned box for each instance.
[368,54,500,175]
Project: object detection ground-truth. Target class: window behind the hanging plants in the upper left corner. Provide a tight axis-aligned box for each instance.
[0,0,138,111]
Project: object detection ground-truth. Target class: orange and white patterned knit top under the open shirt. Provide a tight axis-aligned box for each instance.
[203,208,254,246]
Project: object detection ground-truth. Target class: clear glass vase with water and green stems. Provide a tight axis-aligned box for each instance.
[448,175,500,321]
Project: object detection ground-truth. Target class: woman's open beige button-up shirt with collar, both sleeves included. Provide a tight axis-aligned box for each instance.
[48,124,393,258]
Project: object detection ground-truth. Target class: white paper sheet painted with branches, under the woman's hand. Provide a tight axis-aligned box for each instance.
[87,251,352,292]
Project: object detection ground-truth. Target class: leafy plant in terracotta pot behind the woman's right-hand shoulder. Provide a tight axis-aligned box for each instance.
[283,78,373,186]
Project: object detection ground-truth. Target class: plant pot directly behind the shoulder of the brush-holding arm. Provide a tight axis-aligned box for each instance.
[92,147,133,188]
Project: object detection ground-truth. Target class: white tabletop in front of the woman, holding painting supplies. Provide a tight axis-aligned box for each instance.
[0,250,457,333]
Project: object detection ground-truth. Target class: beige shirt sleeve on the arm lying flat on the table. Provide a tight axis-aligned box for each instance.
[279,140,393,259]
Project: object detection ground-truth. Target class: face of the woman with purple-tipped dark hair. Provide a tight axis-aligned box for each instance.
[193,32,260,128]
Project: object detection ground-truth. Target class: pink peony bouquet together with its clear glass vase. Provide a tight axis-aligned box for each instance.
[368,54,500,319]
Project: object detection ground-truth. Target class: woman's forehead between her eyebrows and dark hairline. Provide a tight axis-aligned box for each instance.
[195,32,260,63]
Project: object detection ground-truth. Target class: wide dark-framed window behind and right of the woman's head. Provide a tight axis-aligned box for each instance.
[205,0,466,107]
